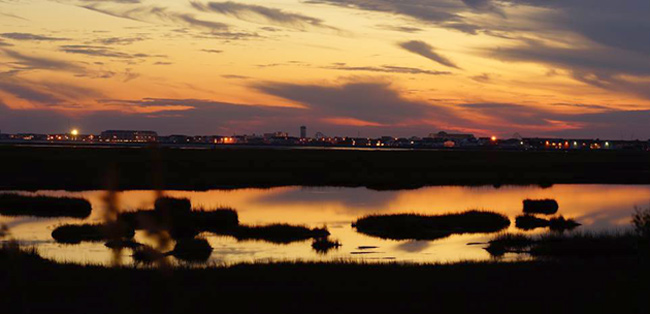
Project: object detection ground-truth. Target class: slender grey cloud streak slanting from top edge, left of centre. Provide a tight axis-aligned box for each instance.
[191,1,333,29]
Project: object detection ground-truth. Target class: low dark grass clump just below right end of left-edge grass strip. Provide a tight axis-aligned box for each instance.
[52,224,135,244]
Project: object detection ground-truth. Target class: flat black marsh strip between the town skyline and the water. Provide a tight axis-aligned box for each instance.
[0,146,650,190]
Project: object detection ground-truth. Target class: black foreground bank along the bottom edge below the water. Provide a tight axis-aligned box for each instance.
[0,248,650,314]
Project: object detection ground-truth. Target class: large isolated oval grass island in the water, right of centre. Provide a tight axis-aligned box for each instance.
[353,210,510,240]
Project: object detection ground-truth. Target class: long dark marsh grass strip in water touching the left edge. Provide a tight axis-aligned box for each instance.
[0,193,92,218]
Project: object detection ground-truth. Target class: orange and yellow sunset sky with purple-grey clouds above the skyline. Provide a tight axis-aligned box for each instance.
[0,0,650,140]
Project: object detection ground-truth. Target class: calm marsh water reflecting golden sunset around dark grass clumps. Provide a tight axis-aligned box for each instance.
[0,185,650,264]
